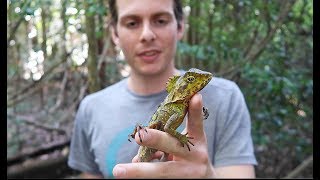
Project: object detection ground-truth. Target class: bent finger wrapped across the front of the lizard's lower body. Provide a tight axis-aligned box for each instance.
[135,129,192,157]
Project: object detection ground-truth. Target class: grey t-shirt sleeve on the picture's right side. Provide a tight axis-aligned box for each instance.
[213,83,257,167]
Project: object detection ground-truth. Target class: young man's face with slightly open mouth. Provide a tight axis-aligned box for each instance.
[112,0,184,75]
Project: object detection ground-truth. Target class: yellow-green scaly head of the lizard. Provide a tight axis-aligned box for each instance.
[171,68,213,100]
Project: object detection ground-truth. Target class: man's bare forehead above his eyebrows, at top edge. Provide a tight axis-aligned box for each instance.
[116,0,174,19]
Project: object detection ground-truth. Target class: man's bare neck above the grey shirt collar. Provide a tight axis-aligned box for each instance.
[128,68,179,95]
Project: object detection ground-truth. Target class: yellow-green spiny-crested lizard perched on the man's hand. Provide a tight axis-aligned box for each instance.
[128,68,213,162]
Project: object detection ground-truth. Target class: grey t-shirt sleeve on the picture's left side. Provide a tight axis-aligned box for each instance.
[68,99,101,175]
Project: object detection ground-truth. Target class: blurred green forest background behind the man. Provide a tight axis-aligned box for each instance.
[7,0,313,178]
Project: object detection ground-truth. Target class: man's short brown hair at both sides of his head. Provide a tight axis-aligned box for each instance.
[109,0,183,28]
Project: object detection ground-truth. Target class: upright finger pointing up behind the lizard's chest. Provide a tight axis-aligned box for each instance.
[186,93,204,140]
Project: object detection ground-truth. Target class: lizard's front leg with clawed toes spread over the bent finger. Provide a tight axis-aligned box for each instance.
[164,113,194,151]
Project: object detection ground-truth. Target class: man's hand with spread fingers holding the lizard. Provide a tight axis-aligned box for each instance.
[113,94,214,178]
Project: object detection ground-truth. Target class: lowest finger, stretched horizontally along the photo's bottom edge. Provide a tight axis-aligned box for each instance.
[113,161,198,178]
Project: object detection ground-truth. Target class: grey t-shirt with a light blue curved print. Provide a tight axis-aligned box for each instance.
[68,72,257,178]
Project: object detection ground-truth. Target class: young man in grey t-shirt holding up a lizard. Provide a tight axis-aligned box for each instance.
[68,0,256,178]
